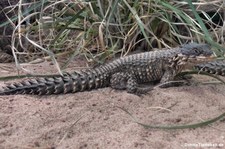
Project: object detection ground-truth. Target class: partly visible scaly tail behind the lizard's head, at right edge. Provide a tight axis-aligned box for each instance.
[194,60,225,76]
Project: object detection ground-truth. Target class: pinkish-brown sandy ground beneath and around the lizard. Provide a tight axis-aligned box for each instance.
[0,62,225,149]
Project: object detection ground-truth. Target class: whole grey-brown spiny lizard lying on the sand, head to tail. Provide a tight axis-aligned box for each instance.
[0,43,214,95]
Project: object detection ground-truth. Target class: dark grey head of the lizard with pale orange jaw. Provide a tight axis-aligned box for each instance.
[176,43,215,67]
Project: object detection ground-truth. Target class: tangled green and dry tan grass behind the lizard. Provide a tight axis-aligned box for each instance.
[0,0,225,71]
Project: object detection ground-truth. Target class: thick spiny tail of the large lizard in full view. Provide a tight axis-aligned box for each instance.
[0,70,109,95]
